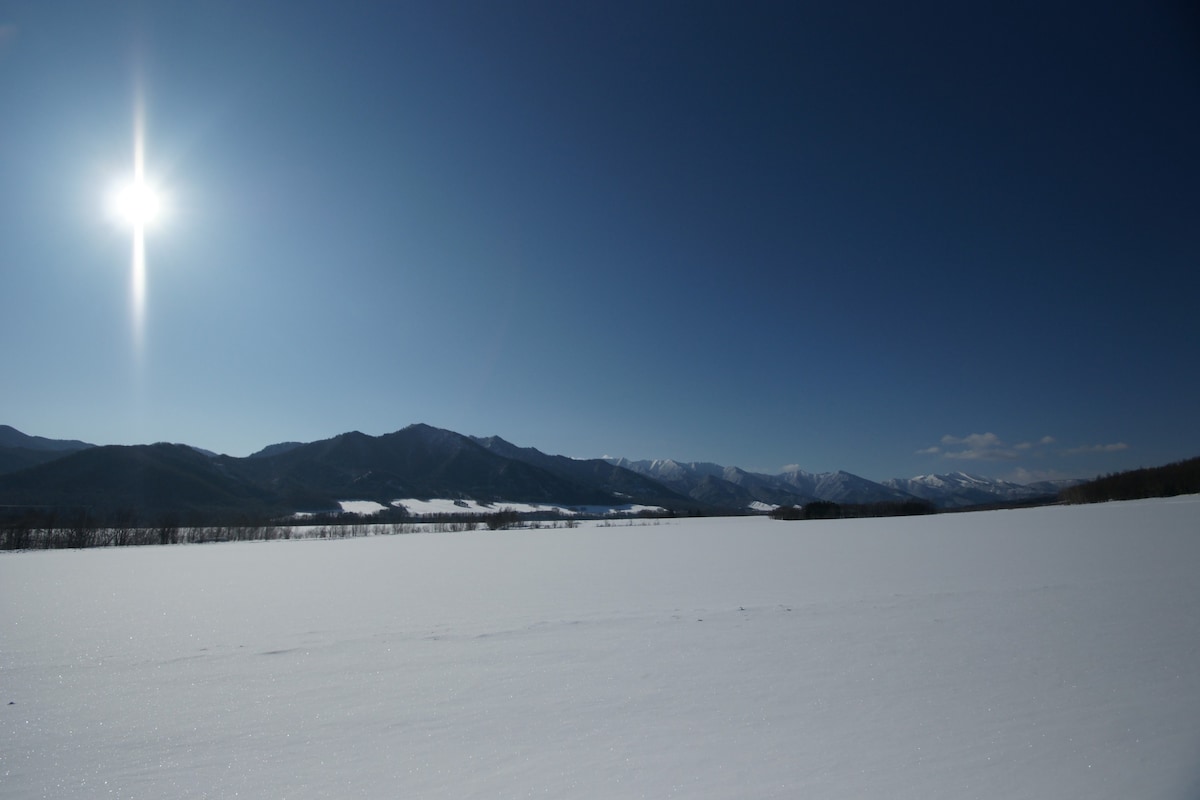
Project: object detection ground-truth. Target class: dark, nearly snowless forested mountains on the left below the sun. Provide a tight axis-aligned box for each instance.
[0,425,701,521]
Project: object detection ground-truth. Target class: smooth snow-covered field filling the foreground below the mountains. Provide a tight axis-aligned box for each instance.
[0,497,1200,800]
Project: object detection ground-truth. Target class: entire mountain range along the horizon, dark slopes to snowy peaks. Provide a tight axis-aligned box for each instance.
[0,425,1061,518]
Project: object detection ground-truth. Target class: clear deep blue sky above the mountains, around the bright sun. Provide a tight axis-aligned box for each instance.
[0,0,1200,480]
